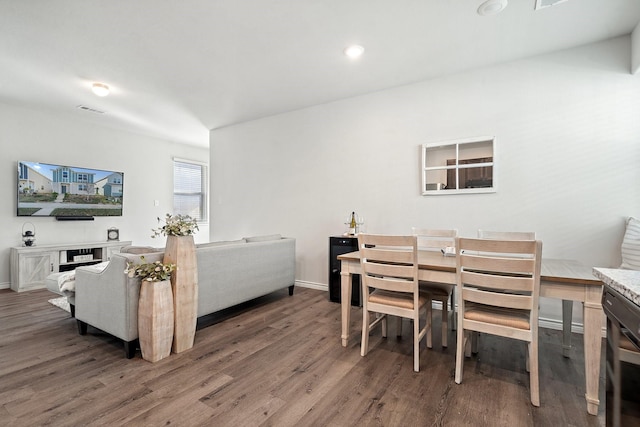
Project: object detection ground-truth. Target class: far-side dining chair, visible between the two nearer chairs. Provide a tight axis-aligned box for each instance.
[413,227,458,348]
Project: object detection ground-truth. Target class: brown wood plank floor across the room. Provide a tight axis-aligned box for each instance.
[0,288,616,427]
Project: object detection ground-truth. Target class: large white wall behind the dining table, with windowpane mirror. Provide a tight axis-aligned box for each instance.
[210,37,640,330]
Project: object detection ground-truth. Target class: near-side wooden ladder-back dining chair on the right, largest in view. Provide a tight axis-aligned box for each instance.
[455,237,542,406]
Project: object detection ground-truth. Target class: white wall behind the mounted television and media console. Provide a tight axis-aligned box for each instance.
[0,104,209,288]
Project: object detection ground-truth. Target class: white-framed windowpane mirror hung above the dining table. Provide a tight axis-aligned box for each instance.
[422,137,495,195]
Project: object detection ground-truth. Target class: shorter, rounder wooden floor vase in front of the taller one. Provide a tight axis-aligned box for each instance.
[138,280,173,362]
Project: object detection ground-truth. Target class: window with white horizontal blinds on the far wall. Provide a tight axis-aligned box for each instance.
[173,159,207,222]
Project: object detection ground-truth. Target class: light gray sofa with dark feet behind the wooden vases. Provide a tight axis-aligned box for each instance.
[75,235,295,358]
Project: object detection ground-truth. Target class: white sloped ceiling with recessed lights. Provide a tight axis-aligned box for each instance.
[0,0,640,147]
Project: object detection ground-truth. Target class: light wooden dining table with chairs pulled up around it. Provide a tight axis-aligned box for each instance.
[338,250,605,415]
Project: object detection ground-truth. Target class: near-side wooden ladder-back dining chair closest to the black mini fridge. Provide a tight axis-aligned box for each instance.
[358,233,431,372]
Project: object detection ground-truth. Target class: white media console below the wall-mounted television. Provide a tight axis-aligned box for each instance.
[11,241,131,292]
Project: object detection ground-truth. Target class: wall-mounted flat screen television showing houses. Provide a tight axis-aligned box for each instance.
[17,161,124,219]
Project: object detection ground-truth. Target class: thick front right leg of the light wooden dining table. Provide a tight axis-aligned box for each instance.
[583,286,604,415]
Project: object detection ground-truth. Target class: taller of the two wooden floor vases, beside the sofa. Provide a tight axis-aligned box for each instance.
[164,236,198,353]
